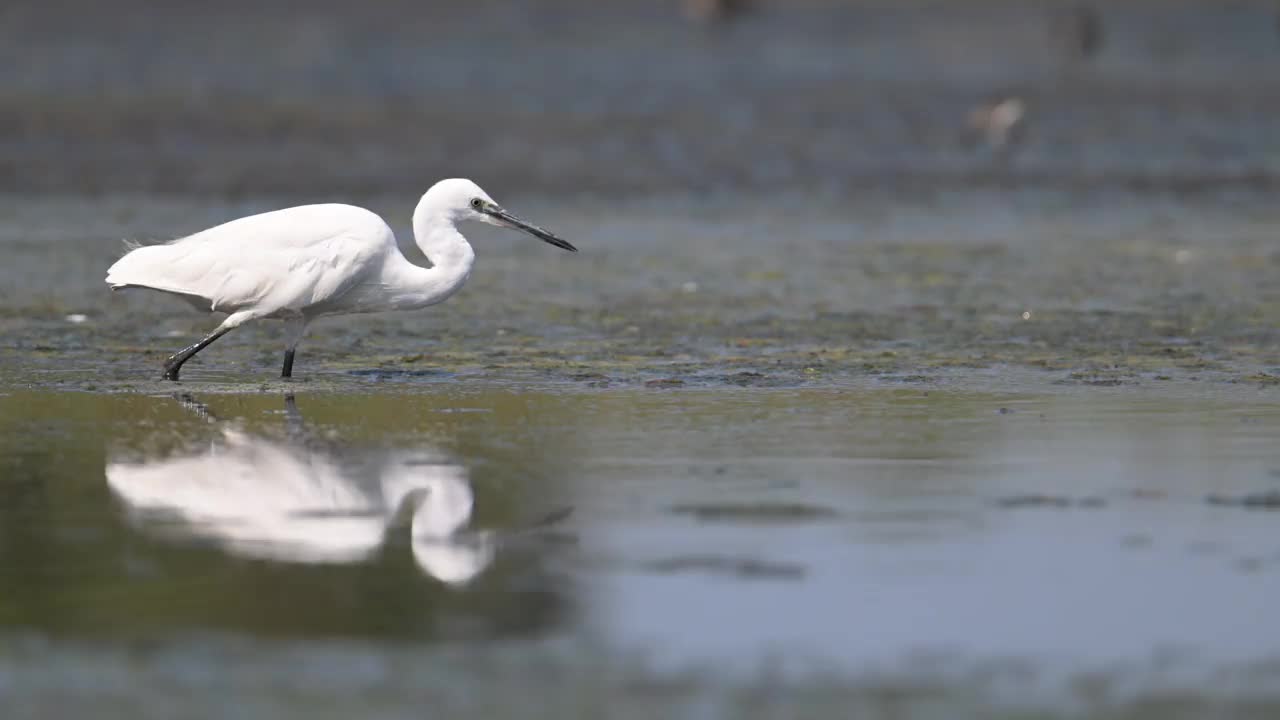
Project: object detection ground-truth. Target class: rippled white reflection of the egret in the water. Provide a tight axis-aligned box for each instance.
[106,397,497,584]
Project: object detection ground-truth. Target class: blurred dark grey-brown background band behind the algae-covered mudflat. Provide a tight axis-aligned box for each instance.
[0,0,1280,196]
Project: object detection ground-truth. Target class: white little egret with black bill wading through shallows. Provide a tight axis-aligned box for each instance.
[106,178,577,380]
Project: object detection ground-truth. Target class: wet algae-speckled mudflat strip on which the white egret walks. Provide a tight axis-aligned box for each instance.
[0,184,1280,397]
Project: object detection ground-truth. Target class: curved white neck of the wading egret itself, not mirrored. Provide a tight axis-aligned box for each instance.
[383,193,476,310]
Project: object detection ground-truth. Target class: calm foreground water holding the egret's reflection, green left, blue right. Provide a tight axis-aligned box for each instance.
[0,384,1280,716]
